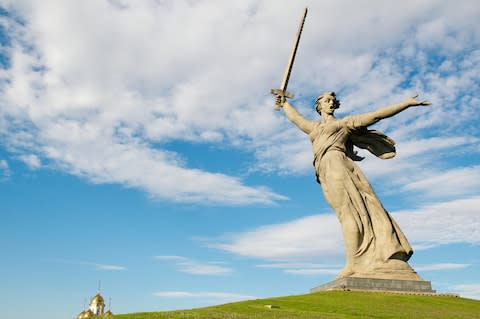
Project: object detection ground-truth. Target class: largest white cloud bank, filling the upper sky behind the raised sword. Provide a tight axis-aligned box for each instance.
[0,0,480,205]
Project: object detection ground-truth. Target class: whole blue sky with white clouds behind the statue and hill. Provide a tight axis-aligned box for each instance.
[0,0,480,319]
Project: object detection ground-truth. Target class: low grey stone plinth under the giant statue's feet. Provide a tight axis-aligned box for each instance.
[310,277,435,293]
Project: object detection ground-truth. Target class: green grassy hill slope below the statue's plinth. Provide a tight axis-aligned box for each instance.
[114,291,480,319]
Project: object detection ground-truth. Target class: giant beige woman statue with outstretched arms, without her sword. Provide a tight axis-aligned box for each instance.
[276,92,430,280]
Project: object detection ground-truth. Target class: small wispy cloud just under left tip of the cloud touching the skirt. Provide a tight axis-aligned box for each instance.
[154,256,233,276]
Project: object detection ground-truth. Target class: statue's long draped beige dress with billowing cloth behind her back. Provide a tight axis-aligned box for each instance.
[310,121,413,271]
